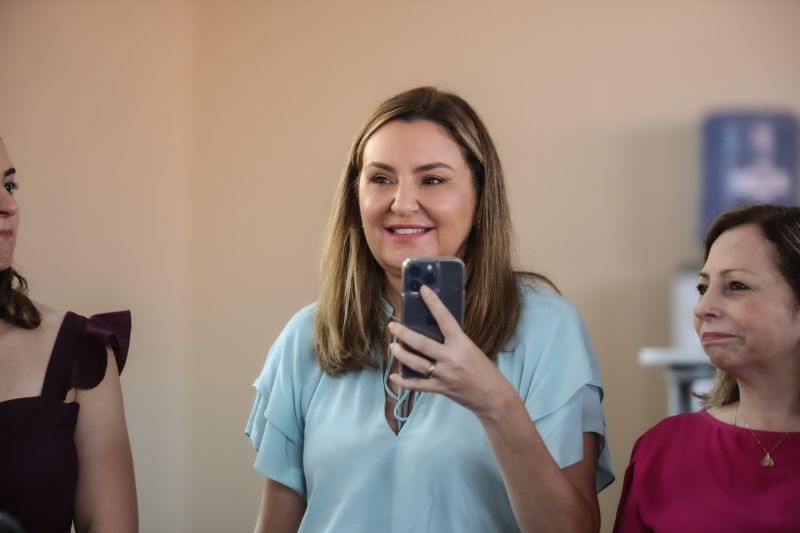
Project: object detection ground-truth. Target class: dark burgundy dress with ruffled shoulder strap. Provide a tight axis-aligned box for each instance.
[0,311,131,533]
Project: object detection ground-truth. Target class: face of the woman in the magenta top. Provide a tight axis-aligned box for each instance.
[694,224,800,378]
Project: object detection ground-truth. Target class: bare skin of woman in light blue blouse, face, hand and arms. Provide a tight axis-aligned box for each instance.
[255,120,600,533]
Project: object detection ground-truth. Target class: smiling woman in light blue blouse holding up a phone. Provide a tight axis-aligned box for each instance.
[246,87,613,533]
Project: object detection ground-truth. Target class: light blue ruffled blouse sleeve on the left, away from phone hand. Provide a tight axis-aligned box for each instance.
[245,308,322,499]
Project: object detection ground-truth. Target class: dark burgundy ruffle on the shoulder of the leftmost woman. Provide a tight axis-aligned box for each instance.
[70,311,131,389]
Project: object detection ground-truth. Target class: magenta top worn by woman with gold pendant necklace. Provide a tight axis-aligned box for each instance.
[614,411,800,533]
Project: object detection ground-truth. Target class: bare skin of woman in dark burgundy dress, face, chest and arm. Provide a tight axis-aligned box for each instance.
[0,141,138,533]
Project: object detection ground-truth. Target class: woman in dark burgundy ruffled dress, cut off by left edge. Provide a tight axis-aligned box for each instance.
[0,139,138,533]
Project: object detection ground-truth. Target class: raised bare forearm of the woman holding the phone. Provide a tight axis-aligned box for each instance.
[476,384,600,533]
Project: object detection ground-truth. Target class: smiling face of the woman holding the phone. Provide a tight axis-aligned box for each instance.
[358,120,477,288]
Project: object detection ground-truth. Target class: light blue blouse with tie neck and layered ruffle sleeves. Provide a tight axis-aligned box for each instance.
[245,284,614,533]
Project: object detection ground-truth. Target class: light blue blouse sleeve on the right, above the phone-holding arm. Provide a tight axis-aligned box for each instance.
[498,286,614,491]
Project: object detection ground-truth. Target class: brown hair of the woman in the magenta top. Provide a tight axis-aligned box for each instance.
[699,204,800,407]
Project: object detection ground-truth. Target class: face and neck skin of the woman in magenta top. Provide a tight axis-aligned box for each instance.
[695,224,800,431]
